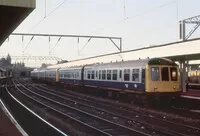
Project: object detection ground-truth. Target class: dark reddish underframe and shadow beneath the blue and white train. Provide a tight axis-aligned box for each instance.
[34,77,181,105]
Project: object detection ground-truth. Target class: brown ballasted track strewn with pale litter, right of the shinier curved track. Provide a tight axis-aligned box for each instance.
[19,79,200,136]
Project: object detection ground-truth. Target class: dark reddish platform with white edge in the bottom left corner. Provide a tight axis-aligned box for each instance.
[0,99,28,136]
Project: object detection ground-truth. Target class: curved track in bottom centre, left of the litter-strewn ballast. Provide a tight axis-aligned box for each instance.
[10,79,150,136]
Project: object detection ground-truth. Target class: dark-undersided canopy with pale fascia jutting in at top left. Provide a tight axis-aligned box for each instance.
[0,0,36,45]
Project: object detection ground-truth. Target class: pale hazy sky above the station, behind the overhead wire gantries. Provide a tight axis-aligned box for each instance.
[0,0,200,64]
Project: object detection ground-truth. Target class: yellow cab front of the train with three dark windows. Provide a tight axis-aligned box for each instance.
[145,58,180,96]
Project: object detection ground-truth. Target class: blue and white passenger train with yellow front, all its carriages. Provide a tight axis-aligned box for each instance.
[31,58,180,98]
